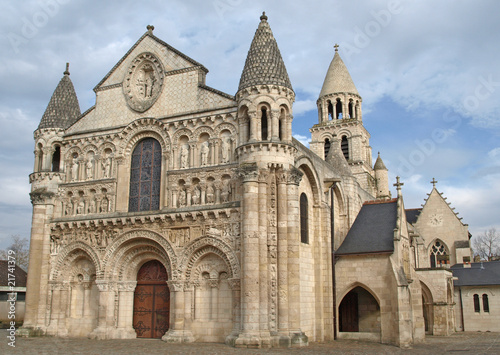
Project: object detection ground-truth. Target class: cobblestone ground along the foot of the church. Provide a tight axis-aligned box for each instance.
[0,330,500,355]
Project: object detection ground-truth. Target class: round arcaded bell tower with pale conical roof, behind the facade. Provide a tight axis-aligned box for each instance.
[310,44,375,195]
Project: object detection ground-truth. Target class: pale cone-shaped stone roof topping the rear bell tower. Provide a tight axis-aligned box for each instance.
[319,50,359,97]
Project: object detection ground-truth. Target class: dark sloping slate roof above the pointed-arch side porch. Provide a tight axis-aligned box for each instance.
[335,198,398,255]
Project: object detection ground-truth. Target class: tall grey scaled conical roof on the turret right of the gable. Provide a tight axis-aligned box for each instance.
[238,13,293,91]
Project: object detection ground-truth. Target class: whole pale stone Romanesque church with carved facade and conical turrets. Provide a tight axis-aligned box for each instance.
[19,14,470,348]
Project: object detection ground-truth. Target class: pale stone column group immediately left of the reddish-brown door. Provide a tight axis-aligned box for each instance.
[116,281,137,339]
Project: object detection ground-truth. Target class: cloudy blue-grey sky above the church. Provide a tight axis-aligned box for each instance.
[0,0,500,249]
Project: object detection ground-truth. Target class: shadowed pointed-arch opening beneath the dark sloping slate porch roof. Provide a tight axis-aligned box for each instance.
[339,286,380,333]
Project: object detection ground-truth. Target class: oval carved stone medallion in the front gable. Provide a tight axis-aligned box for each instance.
[123,53,164,112]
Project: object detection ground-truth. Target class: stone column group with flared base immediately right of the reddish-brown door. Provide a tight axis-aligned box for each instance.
[161,280,194,343]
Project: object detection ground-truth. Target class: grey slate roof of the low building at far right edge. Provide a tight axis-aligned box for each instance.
[451,261,500,286]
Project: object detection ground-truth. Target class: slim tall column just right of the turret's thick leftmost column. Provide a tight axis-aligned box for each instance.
[259,170,271,347]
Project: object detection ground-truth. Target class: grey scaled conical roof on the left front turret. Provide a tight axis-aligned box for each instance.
[38,68,81,129]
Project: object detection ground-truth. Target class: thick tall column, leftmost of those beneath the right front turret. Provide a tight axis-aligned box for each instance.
[235,165,264,348]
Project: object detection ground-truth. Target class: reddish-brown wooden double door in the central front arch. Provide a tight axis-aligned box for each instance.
[133,260,170,338]
